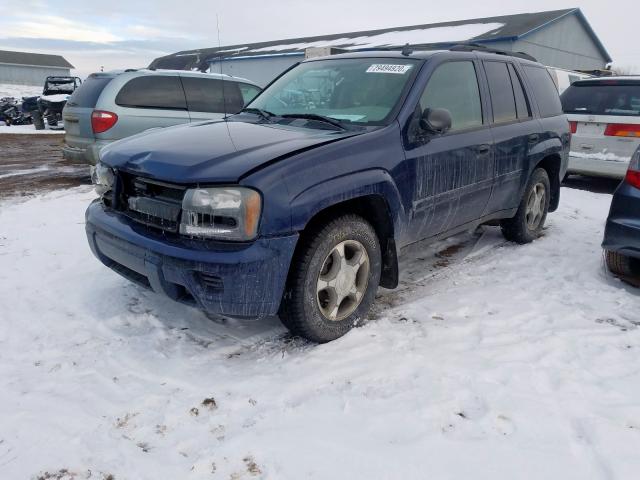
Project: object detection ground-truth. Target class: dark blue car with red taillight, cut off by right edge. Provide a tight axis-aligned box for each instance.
[602,147,640,283]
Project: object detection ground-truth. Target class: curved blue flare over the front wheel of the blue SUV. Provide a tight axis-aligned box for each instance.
[291,168,407,237]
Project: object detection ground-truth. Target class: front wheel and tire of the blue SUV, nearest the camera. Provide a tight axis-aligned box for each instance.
[279,215,382,343]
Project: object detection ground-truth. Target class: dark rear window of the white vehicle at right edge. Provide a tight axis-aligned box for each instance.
[560,82,640,116]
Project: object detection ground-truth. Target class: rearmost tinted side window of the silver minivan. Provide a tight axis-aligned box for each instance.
[116,76,187,110]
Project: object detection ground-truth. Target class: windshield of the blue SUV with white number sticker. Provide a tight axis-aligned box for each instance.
[249,58,418,125]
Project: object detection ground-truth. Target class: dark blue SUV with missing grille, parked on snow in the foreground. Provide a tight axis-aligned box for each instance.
[86,48,570,342]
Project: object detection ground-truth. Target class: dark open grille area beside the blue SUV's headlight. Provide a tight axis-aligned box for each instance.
[120,173,186,233]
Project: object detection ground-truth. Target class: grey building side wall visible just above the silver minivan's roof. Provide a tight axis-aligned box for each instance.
[209,55,304,87]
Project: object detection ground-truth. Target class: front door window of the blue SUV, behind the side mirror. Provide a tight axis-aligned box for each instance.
[420,61,482,130]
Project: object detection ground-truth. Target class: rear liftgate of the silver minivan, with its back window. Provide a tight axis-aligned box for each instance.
[62,73,114,148]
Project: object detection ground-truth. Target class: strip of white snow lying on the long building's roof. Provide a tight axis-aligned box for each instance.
[248,23,504,53]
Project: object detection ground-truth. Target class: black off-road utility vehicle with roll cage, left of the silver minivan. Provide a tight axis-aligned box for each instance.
[23,77,82,130]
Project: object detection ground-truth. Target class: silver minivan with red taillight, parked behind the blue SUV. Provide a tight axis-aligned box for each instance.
[63,70,260,164]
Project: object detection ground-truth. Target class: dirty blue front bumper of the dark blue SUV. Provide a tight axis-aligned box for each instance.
[85,200,298,317]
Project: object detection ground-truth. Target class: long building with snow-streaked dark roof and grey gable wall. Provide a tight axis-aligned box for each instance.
[150,8,612,85]
